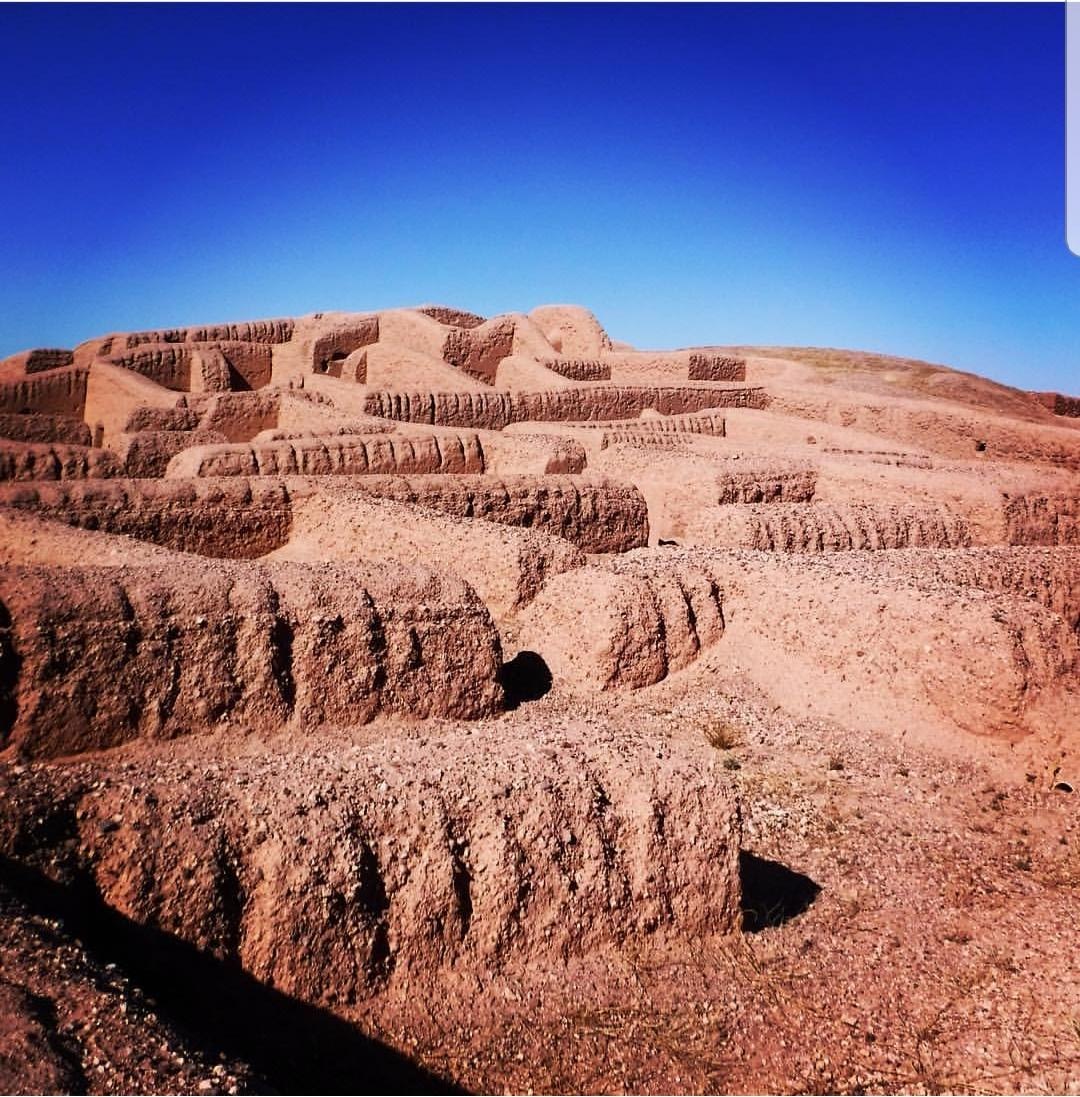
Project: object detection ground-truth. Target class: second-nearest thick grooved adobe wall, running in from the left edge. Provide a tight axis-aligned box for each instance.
[0,563,502,758]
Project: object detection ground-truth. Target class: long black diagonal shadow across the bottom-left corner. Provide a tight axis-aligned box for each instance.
[0,858,465,1094]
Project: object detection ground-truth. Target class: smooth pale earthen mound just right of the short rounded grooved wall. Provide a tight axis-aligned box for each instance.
[671,550,1080,749]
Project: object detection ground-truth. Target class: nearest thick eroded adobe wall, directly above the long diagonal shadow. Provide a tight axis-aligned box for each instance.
[0,728,740,1009]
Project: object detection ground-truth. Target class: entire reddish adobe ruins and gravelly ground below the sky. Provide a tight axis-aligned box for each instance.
[0,306,1080,1094]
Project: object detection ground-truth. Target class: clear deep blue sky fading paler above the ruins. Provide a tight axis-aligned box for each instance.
[0,4,1080,392]
